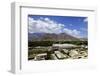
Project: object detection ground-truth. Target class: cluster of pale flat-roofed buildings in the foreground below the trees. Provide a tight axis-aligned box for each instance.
[31,44,88,61]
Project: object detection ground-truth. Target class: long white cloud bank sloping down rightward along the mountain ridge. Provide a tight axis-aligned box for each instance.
[28,17,80,37]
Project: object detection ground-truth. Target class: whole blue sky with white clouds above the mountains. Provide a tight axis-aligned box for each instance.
[28,15,88,38]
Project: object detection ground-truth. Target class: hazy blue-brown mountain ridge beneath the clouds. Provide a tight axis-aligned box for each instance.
[28,33,80,41]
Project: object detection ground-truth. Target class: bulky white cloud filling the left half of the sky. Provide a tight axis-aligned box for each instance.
[29,17,64,33]
